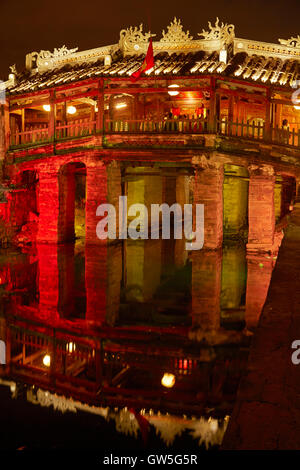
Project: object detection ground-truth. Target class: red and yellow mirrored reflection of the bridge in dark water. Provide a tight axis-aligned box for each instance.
[0,240,275,446]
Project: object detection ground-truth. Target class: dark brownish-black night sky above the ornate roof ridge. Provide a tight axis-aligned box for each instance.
[0,0,300,80]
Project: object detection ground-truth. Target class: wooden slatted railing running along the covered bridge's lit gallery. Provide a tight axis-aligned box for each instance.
[10,118,300,147]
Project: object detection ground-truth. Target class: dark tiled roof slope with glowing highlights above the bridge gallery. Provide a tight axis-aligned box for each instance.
[9,51,300,95]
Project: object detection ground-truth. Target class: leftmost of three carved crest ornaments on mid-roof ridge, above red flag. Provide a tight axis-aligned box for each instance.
[119,23,156,54]
